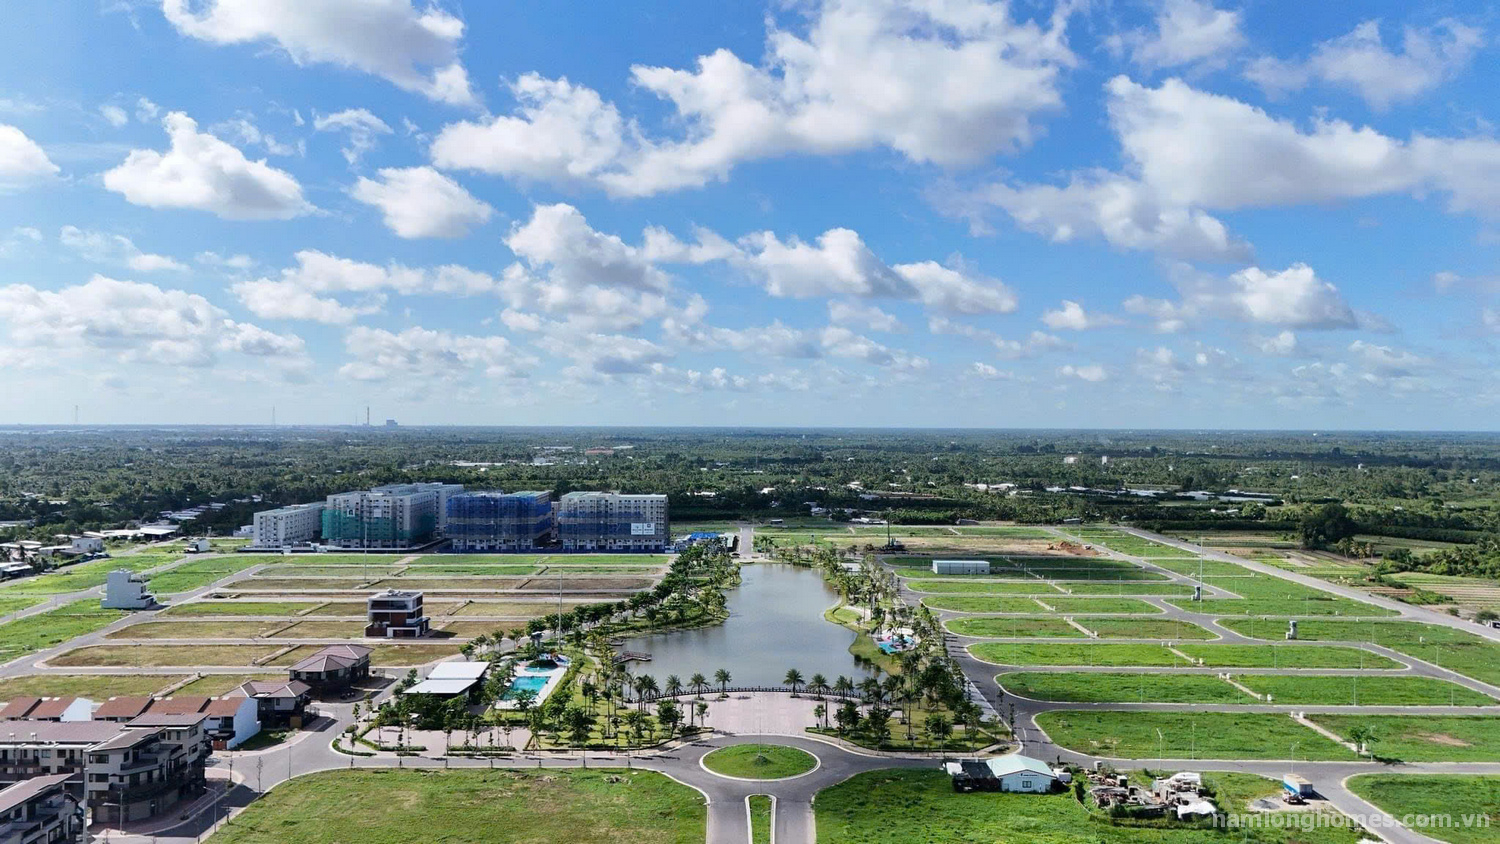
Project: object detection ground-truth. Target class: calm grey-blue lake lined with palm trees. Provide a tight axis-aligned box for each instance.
[621,564,869,685]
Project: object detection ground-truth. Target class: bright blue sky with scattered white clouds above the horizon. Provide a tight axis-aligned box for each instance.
[0,0,1500,429]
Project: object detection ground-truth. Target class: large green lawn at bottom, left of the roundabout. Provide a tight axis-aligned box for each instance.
[215,769,708,844]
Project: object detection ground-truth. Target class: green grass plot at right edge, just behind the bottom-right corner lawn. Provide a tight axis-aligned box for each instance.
[1308,715,1500,762]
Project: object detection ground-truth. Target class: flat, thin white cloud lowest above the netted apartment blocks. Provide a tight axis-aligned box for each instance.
[339,325,536,381]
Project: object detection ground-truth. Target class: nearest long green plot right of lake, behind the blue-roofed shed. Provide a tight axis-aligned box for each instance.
[1037,709,1355,760]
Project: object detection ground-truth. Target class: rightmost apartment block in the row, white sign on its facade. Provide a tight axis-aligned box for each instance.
[557,492,669,553]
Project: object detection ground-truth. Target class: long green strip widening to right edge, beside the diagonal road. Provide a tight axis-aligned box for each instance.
[1220,619,1500,685]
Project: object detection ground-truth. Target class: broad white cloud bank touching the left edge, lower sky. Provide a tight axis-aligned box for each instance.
[0,276,303,366]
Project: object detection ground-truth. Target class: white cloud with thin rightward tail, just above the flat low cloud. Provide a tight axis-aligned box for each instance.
[231,249,498,325]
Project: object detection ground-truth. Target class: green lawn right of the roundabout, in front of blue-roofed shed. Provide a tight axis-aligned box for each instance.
[816,769,1359,844]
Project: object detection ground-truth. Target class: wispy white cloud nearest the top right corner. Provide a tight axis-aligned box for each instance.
[1245,19,1485,111]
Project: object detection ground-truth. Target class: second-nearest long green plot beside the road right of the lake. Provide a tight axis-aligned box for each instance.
[995,672,1254,703]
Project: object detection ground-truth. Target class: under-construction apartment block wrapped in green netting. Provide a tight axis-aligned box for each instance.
[323,484,464,550]
